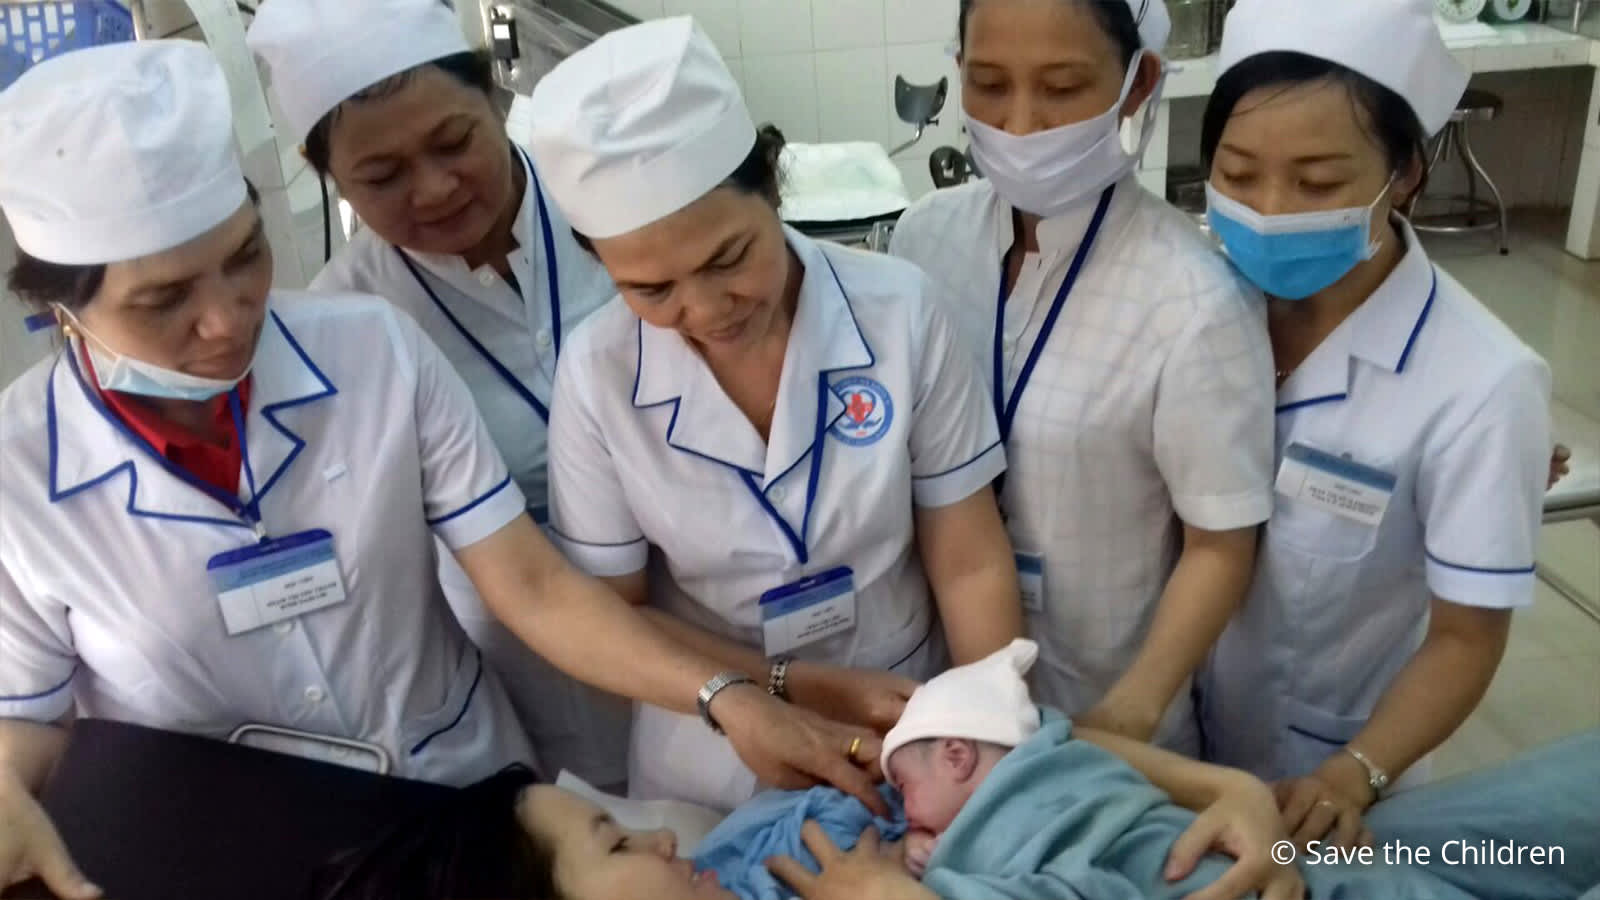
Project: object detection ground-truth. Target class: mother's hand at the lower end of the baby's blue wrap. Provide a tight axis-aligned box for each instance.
[1165,772,1306,900]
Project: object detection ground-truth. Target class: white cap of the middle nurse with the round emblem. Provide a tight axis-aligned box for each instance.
[528,16,755,239]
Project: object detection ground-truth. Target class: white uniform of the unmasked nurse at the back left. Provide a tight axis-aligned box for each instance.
[312,147,629,785]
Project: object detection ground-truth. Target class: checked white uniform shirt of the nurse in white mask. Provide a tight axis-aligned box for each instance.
[891,178,1272,754]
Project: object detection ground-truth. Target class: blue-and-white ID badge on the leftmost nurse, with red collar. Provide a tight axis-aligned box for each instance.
[205,528,344,637]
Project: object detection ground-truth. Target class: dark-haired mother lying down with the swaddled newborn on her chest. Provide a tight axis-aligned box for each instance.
[312,641,1600,900]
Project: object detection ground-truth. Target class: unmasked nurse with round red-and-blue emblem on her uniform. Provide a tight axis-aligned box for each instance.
[530,18,1021,807]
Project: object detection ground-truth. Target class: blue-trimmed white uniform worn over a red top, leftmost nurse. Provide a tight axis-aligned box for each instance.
[0,293,531,785]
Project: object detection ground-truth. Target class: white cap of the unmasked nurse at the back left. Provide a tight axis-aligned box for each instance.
[245,0,472,141]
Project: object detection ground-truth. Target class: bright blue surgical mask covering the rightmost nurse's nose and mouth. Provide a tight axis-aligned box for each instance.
[1205,181,1394,299]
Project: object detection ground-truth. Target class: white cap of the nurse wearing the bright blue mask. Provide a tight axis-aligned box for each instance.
[1218,0,1469,135]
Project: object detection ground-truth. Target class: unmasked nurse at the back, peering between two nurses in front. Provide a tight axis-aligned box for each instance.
[248,0,629,785]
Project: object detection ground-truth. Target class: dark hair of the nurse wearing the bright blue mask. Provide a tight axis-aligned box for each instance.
[1200,51,1427,201]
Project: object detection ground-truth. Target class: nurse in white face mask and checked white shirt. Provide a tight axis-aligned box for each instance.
[891,0,1272,756]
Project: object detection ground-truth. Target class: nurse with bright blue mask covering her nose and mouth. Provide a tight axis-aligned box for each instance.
[1202,0,1550,844]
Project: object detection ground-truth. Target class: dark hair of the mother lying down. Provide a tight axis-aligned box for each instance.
[307,765,562,900]
